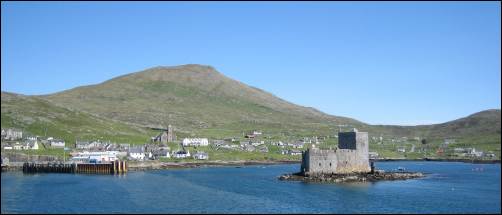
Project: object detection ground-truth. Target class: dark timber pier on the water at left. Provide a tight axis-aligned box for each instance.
[23,161,127,174]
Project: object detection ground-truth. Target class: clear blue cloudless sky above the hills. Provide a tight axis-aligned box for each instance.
[1,2,501,125]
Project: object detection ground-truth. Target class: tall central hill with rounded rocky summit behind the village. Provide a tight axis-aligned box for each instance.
[42,65,363,136]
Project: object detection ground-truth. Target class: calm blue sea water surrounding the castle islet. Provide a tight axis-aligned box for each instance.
[1,162,501,213]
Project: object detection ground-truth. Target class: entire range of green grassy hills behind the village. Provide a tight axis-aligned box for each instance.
[1,65,500,159]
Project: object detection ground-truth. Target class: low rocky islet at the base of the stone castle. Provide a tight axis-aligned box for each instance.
[278,170,425,183]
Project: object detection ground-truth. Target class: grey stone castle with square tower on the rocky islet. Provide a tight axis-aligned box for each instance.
[301,129,371,175]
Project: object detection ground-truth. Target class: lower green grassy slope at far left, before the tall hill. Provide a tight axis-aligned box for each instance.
[1,92,155,143]
